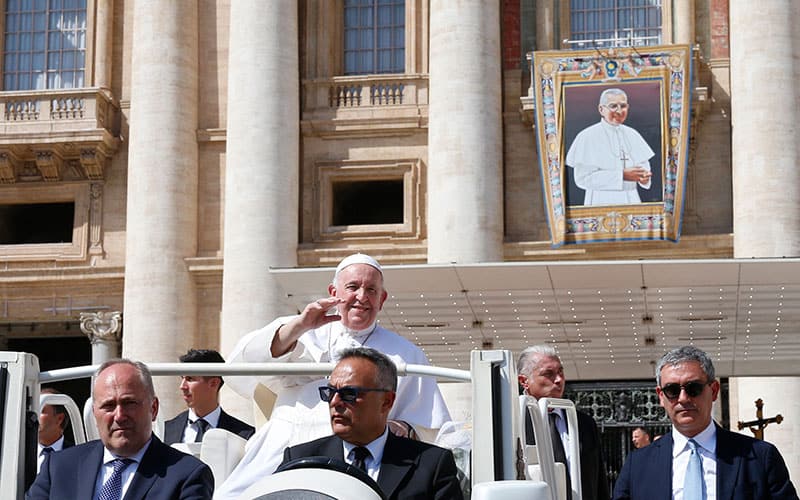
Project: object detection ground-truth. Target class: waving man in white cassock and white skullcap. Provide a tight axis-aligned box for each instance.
[214,254,450,499]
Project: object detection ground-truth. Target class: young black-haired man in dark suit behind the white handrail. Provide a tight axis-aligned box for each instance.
[164,349,255,444]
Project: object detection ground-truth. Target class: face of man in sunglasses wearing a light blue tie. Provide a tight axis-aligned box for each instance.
[656,361,719,438]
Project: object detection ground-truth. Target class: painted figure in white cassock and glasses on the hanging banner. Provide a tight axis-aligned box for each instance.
[566,88,655,205]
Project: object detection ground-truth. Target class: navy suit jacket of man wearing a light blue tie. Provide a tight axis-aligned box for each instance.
[614,426,797,500]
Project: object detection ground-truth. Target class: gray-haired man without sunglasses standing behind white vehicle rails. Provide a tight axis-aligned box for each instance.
[517,345,609,500]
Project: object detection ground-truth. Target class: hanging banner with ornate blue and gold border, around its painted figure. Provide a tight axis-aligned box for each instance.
[533,45,691,246]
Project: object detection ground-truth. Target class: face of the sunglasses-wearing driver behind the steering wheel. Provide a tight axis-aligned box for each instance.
[328,357,395,446]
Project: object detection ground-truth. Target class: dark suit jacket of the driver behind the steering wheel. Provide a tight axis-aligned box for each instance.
[283,432,463,500]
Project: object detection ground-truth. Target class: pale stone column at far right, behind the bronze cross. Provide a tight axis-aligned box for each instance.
[730,0,800,478]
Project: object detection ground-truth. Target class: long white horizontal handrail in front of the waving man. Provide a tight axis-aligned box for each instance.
[39,363,472,384]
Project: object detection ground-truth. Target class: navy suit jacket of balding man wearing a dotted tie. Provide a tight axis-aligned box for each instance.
[25,436,214,500]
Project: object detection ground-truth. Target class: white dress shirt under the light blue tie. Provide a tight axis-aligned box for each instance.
[672,420,717,500]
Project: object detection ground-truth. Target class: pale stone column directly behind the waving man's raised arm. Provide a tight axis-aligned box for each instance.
[220,0,300,410]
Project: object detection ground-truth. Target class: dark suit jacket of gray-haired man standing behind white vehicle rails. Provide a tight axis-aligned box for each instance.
[525,411,610,500]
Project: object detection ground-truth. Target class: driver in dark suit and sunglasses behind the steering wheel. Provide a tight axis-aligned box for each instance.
[284,347,462,500]
